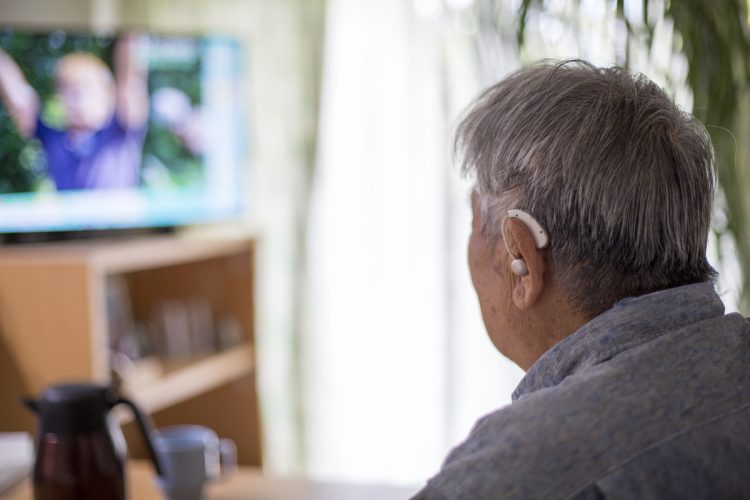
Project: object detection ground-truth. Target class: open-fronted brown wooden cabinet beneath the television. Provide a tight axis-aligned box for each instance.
[0,236,261,465]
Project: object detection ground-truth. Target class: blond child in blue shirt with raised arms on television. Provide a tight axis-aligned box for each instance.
[0,35,149,190]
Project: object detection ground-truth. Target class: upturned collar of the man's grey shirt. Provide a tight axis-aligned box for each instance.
[512,283,724,401]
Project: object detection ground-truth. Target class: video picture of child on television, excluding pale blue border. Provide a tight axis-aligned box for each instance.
[0,31,212,193]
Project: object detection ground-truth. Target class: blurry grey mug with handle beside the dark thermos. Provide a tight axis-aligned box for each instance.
[152,425,237,500]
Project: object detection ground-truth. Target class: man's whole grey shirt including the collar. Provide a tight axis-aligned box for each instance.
[414,283,750,500]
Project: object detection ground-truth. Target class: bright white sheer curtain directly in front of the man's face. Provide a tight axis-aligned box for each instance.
[303,0,521,483]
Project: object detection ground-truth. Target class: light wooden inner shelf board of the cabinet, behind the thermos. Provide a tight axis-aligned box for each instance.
[123,344,255,414]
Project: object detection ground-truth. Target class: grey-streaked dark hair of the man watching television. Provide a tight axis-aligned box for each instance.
[455,61,716,315]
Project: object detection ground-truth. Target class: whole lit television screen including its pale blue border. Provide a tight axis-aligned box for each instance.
[0,30,247,233]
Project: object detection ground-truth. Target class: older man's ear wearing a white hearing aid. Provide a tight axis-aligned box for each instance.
[504,218,545,309]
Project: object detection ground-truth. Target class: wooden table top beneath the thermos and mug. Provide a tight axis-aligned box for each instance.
[0,461,419,500]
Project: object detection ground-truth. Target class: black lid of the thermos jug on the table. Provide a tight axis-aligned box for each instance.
[38,383,116,434]
